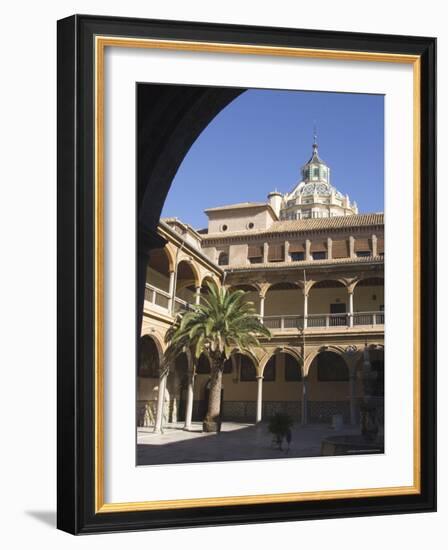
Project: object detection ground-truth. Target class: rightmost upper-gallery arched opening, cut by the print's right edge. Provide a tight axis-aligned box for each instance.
[353,277,384,325]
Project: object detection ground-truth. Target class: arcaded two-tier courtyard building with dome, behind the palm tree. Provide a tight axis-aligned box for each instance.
[137,143,385,431]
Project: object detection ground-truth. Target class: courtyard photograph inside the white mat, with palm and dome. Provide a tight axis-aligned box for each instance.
[135,82,384,467]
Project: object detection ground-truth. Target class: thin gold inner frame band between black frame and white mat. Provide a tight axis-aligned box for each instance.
[94,36,421,513]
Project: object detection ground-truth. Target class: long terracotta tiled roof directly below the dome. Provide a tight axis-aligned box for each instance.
[204,212,384,239]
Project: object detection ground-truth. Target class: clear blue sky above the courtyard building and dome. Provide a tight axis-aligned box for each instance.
[162,90,384,229]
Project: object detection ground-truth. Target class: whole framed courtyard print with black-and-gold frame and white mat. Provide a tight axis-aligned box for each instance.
[58,16,436,534]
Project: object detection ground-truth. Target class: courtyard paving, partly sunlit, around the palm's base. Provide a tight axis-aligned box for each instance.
[137,422,359,465]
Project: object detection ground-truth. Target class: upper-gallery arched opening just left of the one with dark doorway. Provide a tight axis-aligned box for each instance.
[264,282,303,330]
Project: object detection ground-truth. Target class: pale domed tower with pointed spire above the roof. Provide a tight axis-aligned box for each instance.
[280,135,358,220]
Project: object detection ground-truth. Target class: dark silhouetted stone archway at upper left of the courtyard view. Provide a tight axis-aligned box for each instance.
[137,84,246,337]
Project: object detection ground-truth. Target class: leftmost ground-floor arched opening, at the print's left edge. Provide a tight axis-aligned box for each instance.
[137,334,162,427]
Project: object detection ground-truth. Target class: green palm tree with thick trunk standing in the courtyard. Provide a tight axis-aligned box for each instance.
[165,281,271,432]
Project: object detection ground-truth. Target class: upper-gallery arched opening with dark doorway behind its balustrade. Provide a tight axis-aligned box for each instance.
[307,280,348,328]
